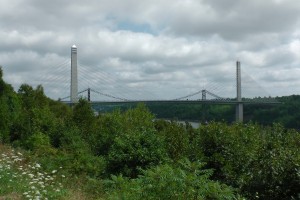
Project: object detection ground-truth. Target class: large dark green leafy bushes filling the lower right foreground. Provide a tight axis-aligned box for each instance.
[193,123,300,199]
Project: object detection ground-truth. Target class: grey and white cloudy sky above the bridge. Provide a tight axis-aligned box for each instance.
[0,0,300,99]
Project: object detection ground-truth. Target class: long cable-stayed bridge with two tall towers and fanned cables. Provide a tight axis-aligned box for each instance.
[37,46,278,121]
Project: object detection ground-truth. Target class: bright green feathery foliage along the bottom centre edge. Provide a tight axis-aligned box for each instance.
[107,159,238,199]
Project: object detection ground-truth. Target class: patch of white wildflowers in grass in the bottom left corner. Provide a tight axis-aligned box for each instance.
[0,145,68,199]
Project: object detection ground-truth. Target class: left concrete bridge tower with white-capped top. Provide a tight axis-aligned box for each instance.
[71,45,78,103]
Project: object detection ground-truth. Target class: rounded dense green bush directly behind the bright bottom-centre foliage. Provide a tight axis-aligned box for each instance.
[107,131,167,177]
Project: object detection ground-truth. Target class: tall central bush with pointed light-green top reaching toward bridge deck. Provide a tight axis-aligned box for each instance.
[106,105,167,177]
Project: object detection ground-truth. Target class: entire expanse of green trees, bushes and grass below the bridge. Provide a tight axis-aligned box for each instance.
[0,69,300,200]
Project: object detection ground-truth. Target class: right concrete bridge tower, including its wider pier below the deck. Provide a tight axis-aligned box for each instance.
[236,61,243,122]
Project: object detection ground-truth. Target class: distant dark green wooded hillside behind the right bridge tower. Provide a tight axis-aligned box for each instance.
[138,95,300,130]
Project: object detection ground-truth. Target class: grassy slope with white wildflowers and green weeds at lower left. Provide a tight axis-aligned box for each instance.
[0,143,107,200]
